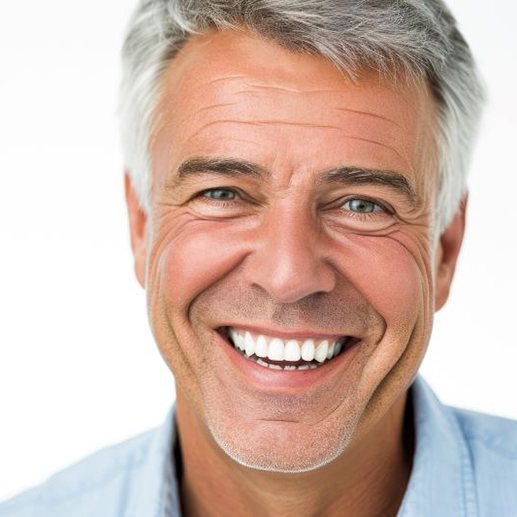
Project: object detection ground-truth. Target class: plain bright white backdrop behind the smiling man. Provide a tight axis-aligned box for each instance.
[0,0,517,500]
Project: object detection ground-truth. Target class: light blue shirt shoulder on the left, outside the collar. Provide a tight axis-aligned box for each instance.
[0,430,157,517]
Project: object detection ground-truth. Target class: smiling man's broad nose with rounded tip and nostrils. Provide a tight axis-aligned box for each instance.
[246,207,336,303]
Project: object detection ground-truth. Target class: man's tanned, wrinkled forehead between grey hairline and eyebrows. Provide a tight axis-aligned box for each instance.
[151,31,436,191]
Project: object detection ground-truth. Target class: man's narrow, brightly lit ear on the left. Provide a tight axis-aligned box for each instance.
[124,172,147,289]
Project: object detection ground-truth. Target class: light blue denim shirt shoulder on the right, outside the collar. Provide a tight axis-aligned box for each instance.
[451,408,517,515]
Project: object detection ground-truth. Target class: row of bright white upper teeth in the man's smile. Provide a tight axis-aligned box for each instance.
[229,328,343,363]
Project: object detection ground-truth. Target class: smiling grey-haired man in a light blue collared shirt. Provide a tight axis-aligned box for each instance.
[0,0,517,516]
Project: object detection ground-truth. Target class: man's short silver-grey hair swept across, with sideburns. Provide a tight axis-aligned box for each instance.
[120,0,483,232]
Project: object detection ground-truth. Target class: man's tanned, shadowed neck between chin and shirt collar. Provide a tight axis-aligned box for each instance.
[177,392,413,517]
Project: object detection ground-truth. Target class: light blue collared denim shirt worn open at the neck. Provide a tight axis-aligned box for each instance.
[0,377,517,517]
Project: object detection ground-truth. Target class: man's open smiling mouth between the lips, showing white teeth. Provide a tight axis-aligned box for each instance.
[219,327,359,371]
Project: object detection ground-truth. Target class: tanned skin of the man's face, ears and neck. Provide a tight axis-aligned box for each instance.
[126,31,464,515]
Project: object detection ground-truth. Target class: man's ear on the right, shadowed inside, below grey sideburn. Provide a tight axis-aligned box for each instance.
[435,196,467,311]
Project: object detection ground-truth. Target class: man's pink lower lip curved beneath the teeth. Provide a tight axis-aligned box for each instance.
[219,335,360,390]
